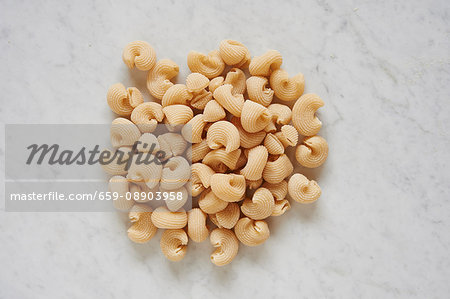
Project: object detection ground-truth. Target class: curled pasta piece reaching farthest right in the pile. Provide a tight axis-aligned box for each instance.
[295,135,328,168]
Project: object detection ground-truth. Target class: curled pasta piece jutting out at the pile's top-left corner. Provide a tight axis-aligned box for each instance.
[122,40,156,71]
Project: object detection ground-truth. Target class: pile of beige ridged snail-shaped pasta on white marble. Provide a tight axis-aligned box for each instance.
[105,40,328,266]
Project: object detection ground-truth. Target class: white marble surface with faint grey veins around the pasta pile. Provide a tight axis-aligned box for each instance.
[0,0,450,298]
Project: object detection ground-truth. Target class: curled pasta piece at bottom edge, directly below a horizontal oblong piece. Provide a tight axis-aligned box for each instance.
[160,229,188,262]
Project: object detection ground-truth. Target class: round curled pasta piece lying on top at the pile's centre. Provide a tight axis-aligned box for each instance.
[206,120,240,153]
